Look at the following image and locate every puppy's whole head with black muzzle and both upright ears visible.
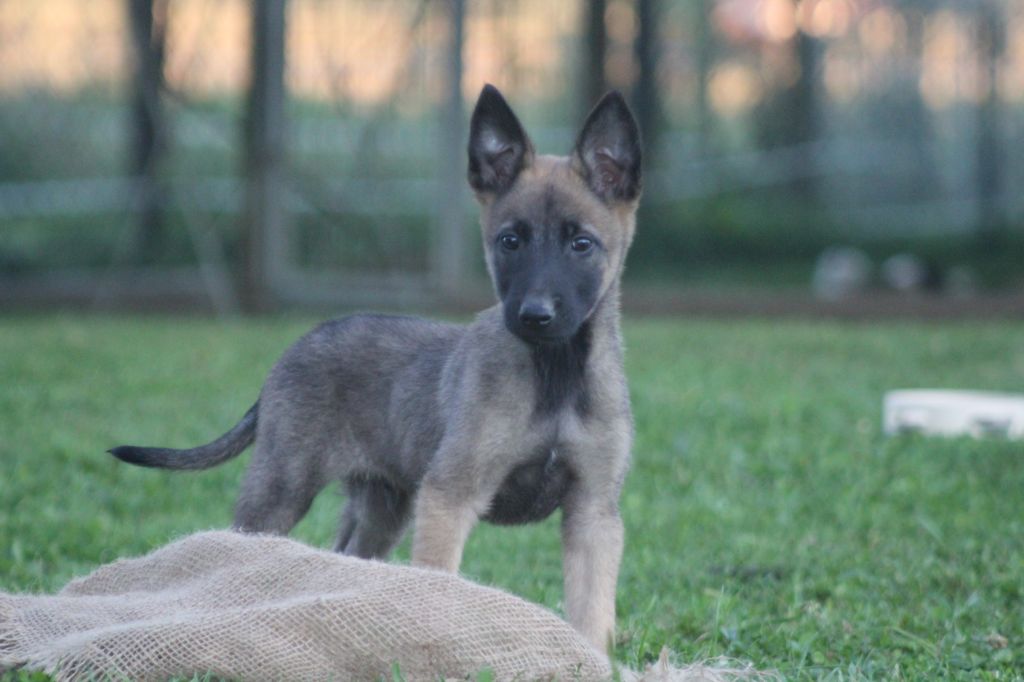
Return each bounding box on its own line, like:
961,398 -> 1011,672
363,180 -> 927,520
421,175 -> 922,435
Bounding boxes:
469,85 -> 640,343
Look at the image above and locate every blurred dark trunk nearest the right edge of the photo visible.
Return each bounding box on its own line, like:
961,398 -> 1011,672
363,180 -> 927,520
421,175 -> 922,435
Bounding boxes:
976,2 -> 1006,246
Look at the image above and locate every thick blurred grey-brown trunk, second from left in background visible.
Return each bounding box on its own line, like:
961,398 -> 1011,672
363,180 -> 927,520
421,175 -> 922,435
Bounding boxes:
242,0 -> 288,312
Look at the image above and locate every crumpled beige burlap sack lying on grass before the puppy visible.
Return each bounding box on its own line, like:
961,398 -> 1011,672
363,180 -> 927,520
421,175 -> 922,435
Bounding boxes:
0,531 -> 765,680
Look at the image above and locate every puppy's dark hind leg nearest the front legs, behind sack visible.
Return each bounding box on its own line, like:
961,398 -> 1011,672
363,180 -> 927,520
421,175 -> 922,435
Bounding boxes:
335,478 -> 411,559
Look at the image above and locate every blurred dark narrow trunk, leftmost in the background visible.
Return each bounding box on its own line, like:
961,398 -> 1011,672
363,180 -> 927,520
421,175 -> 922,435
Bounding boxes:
128,0 -> 167,264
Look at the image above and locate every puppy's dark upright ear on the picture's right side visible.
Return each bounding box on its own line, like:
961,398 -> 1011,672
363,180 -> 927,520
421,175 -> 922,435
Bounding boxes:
574,91 -> 643,204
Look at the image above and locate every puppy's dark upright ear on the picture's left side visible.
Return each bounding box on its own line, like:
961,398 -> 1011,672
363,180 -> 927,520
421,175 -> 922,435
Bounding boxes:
469,84 -> 534,196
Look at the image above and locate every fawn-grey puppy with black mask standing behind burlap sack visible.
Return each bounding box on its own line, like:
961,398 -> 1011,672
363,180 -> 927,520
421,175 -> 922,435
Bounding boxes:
111,85 -> 641,648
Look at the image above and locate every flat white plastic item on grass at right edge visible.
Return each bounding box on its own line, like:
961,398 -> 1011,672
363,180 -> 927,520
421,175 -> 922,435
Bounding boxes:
884,389 -> 1024,439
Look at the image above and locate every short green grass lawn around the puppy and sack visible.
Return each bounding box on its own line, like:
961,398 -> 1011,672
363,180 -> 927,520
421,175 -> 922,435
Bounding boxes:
0,316 -> 1024,680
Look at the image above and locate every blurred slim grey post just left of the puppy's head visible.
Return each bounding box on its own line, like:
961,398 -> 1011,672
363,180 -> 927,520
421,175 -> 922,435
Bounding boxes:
434,0 -> 466,299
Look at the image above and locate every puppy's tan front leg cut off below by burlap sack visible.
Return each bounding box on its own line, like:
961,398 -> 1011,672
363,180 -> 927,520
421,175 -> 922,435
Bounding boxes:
413,481 -> 477,572
